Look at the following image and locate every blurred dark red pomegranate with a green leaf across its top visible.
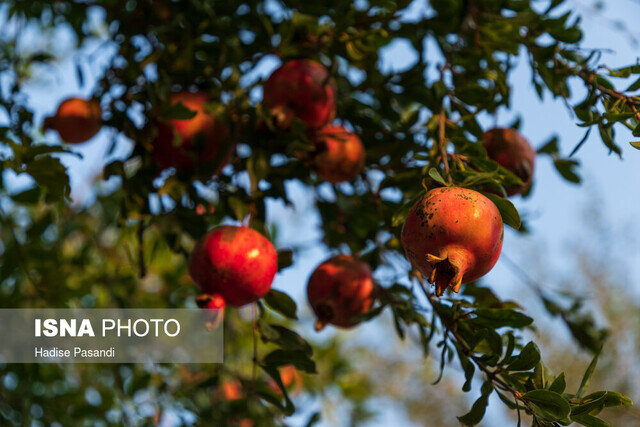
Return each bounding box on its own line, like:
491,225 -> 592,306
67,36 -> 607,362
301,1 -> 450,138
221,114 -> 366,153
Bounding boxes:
152,92 -> 233,175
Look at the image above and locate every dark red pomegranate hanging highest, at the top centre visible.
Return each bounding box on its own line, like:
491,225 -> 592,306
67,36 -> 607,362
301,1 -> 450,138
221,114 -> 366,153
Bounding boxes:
263,59 -> 337,129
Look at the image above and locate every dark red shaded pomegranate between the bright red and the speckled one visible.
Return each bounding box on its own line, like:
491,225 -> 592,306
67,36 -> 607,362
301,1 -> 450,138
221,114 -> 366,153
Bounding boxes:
307,255 -> 375,330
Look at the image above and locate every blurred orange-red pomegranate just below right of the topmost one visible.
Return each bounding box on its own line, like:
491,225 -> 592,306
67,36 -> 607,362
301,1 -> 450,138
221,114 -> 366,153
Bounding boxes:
313,125 -> 366,183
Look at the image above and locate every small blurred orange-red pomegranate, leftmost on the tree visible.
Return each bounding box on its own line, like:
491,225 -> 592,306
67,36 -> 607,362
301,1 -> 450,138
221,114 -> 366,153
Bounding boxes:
44,97 -> 102,144
